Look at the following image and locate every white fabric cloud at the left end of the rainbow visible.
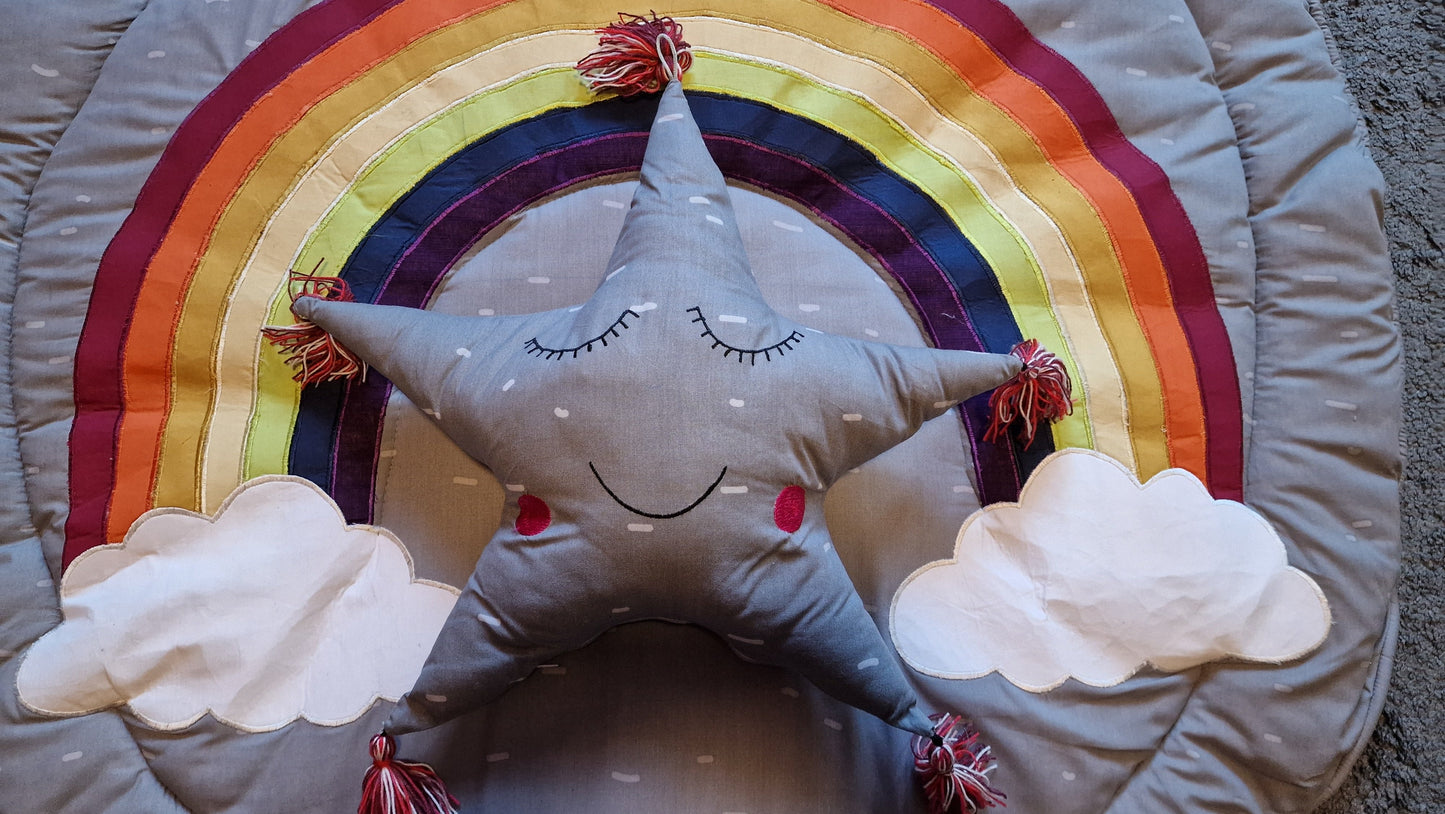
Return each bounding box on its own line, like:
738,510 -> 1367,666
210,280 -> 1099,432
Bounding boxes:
16,476 -> 457,732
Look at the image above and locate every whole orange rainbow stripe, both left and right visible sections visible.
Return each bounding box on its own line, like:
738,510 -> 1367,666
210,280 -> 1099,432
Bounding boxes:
107,0 -> 1205,539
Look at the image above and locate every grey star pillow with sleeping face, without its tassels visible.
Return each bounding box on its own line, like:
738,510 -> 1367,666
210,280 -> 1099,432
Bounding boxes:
295,81 -> 1020,736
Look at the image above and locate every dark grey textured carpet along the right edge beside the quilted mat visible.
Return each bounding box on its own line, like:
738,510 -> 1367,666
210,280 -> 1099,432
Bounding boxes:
1319,0 -> 1445,814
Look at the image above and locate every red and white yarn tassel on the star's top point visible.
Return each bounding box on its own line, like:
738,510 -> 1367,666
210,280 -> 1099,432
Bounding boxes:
577,12 -> 692,95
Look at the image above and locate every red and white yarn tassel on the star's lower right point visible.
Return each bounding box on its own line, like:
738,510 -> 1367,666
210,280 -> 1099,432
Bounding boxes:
913,713 -> 1006,814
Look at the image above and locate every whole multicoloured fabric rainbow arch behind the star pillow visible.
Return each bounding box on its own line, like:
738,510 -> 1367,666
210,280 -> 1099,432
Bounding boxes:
65,0 -> 1243,562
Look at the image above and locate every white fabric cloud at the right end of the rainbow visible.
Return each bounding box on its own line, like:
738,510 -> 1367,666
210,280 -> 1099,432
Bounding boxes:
892,450 -> 1329,693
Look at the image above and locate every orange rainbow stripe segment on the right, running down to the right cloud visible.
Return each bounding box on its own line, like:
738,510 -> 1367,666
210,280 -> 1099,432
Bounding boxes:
821,0 -> 1208,480
